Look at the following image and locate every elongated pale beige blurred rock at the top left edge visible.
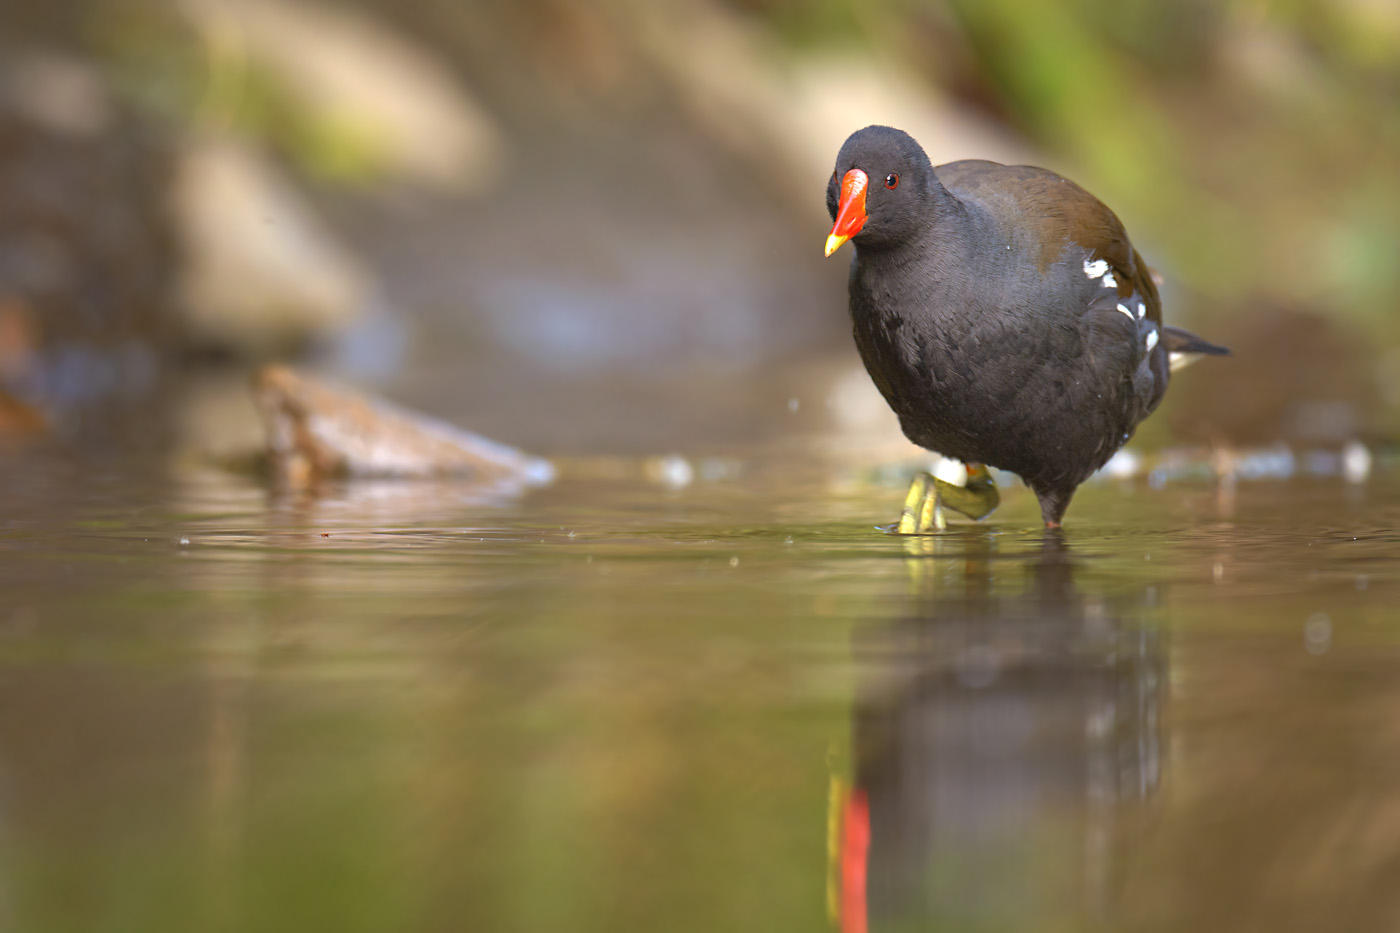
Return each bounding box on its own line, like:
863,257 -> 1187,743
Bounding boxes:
183,0 -> 503,192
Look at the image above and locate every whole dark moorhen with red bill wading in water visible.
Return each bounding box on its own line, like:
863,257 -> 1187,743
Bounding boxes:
826,126 -> 1229,534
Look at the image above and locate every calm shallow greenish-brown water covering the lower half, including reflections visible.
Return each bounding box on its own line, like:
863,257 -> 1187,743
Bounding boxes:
0,451 -> 1400,932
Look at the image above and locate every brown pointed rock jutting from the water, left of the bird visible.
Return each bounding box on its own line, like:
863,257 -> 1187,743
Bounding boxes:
253,366 -> 554,486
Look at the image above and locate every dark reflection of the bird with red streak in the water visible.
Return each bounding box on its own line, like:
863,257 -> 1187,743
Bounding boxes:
832,531 -> 1166,933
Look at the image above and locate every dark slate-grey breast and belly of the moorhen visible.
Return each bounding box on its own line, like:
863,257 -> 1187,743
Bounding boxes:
851,246 -> 1128,475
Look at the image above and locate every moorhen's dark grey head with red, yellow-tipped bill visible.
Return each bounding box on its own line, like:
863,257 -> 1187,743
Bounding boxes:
826,126 -> 934,256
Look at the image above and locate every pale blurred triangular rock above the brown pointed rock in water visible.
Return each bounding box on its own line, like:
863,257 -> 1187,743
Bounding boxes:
174,136 -> 372,356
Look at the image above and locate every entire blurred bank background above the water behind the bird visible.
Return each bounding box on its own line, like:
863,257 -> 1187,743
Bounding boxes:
0,0 -> 1400,452
